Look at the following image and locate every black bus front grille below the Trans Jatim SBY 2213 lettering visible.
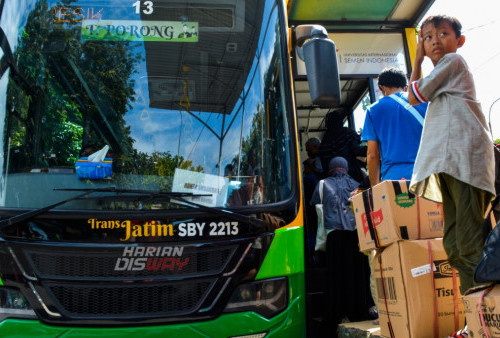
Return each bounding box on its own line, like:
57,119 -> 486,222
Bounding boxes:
0,233 -> 272,326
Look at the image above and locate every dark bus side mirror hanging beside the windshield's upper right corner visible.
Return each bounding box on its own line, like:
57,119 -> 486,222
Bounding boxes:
295,25 -> 340,108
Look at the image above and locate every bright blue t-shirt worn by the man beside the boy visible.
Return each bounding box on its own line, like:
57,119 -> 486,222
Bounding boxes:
361,92 -> 427,181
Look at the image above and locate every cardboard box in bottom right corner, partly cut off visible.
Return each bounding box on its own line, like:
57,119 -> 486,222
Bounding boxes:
464,285 -> 500,338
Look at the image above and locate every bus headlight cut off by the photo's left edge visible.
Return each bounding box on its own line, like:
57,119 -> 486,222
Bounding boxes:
0,287 -> 37,322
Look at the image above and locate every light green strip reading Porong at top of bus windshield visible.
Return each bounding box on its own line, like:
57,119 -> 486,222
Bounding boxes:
81,20 -> 198,42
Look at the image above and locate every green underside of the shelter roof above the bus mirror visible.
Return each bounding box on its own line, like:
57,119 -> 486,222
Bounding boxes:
288,0 -> 434,31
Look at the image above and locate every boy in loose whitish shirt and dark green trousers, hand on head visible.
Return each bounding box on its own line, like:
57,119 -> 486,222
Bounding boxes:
408,15 -> 495,337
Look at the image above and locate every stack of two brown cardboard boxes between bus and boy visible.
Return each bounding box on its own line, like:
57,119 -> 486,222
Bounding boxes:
352,181 -> 465,337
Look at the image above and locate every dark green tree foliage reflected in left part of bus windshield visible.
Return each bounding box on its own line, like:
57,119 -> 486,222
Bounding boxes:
7,1 -> 141,167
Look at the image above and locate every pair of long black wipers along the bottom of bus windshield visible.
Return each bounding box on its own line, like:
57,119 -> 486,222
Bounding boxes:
0,187 -> 265,230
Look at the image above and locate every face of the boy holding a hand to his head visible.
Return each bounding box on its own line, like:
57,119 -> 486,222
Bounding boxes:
422,21 -> 465,66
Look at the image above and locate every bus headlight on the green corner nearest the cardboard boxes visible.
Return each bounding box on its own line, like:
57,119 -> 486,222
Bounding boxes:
224,277 -> 288,318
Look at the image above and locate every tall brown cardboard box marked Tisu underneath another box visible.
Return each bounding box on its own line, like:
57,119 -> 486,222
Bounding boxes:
372,239 -> 465,338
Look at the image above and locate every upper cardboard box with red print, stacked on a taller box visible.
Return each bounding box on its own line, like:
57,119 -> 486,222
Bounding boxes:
352,181 -> 444,251
